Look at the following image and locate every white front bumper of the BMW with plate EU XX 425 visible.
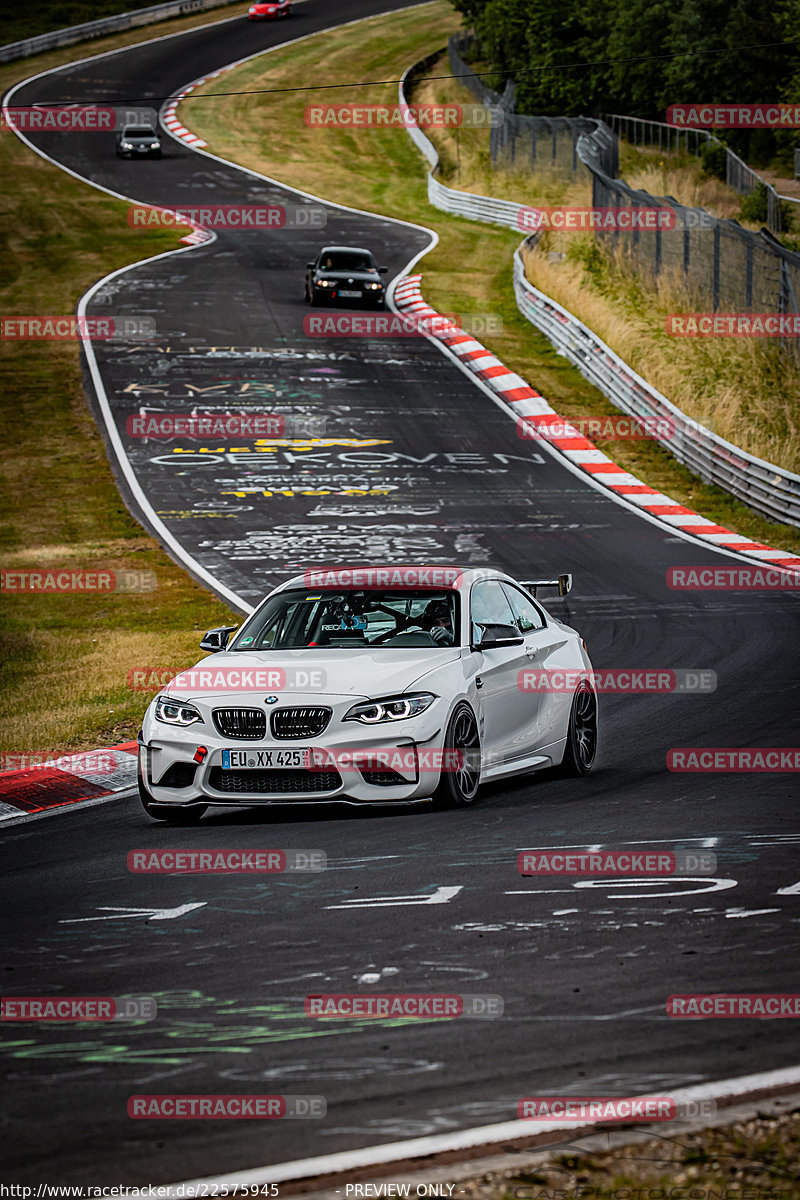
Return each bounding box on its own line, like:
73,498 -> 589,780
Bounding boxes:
139,698 -> 447,808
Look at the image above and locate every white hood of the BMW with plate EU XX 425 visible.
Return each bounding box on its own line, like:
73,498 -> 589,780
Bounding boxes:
164,646 -> 461,703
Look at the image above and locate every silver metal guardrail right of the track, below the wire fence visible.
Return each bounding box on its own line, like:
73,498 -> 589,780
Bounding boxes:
399,56 -> 800,526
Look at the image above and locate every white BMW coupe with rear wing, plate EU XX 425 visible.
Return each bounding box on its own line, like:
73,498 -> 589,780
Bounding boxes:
139,566 -> 597,824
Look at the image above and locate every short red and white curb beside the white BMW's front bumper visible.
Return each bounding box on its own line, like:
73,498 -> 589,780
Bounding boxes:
0,742 -> 139,821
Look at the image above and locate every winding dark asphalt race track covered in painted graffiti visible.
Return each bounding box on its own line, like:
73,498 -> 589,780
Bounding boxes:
0,0 -> 800,1184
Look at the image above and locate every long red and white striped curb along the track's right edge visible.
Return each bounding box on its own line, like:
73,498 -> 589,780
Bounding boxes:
395,275 -> 800,570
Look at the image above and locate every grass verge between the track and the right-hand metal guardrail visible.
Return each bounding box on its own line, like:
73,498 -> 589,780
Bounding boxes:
181,0 -> 800,552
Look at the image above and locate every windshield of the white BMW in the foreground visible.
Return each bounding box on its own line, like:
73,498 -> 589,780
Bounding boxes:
229,588 -> 459,650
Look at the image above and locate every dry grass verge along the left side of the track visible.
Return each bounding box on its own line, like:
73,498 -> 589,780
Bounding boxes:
0,14 -> 247,755
